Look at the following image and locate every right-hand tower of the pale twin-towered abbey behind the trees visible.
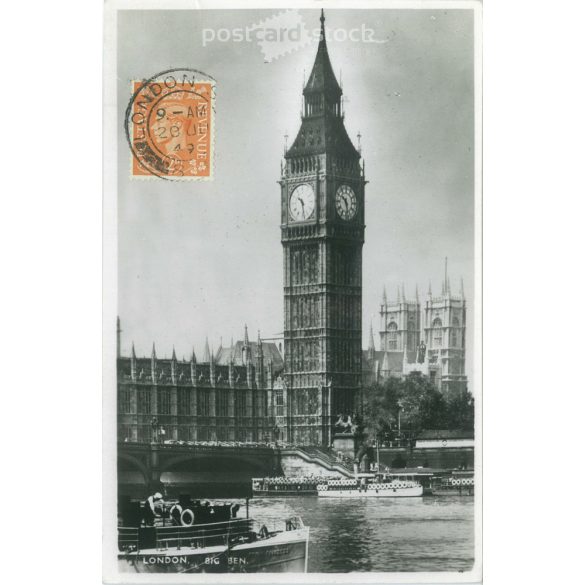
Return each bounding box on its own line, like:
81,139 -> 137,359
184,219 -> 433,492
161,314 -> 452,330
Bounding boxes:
424,258 -> 467,393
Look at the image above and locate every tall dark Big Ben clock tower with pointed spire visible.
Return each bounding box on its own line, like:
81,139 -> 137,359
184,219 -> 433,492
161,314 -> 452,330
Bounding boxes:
280,11 -> 366,445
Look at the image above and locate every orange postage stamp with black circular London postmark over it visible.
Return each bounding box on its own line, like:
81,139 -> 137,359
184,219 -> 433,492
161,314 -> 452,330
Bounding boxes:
124,68 -> 215,180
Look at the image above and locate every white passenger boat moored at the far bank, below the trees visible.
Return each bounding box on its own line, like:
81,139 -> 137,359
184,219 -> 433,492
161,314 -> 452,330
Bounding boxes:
317,473 -> 423,498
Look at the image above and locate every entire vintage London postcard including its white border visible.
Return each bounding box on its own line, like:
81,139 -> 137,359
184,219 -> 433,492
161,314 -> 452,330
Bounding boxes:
103,1 -> 482,583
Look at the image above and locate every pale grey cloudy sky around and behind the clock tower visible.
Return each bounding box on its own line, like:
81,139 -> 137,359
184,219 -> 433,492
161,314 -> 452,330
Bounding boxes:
118,10 -> 474,384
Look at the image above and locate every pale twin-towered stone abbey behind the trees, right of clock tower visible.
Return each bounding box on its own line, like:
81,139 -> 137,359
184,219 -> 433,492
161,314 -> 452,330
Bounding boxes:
363,270 -> 467,393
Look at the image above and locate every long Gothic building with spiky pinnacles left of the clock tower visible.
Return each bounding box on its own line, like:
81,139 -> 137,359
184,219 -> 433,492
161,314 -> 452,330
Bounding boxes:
117,324 -> 286,442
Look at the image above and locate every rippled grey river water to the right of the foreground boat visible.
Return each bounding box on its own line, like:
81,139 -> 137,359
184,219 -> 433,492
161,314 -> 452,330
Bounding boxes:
244,496 -> 474,572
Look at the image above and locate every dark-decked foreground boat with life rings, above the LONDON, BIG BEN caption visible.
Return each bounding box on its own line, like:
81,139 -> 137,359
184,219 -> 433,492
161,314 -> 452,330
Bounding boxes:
118,502 -> 309,573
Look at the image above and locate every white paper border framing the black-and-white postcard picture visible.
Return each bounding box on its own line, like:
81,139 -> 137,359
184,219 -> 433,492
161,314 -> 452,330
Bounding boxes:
102,0 -> 483,584
